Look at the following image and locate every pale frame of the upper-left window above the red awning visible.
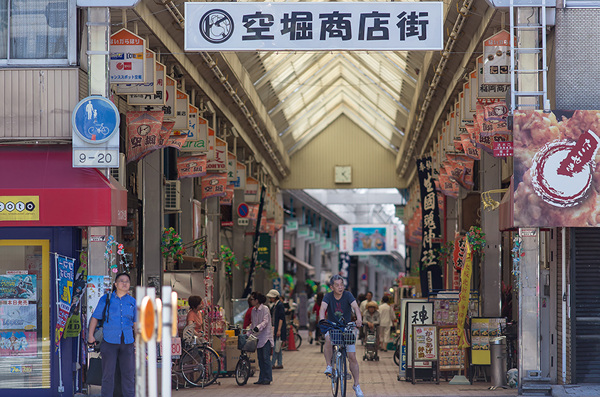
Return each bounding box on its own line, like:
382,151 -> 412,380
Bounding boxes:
0,0 -> 77,68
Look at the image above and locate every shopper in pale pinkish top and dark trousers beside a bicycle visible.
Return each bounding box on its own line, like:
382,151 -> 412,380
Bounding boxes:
250,292 -> 273,385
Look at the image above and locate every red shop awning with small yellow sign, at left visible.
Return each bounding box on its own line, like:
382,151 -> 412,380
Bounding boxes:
0,145 -> 127,227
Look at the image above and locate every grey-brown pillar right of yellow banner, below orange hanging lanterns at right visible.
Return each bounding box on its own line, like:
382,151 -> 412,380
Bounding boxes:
480,150 -> 503,317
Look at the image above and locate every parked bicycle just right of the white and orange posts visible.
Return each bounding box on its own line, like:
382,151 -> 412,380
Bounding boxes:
179,325 -> 221,387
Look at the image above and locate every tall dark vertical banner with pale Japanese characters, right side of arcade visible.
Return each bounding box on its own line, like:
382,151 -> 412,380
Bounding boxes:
417,157 -> 443,296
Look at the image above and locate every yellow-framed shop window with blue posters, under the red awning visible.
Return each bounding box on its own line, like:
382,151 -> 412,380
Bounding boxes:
0,240 -> 51,389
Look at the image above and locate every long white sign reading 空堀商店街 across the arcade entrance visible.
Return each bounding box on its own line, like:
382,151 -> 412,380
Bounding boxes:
184,2 -> 444,51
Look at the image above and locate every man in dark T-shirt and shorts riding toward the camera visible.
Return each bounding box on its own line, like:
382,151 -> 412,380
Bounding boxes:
319,274 -> 364,397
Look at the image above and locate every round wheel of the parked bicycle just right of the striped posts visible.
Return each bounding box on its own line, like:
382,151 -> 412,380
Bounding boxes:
180,348 -> 221,387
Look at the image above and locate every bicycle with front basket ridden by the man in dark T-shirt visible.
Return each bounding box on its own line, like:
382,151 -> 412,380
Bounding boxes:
319,320 -> 356,397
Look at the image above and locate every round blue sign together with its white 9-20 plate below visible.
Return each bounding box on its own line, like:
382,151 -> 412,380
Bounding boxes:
71,96 -> 121,168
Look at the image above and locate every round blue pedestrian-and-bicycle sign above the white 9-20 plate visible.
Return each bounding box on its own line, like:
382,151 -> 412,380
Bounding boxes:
71,96 -> 120,143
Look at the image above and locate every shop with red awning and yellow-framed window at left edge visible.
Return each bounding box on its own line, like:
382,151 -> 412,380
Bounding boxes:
0,145 -> 127,396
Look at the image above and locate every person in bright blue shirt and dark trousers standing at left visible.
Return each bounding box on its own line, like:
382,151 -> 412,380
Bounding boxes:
88,273 -> 137,397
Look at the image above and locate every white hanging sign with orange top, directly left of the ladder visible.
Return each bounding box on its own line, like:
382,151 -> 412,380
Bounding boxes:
483,30 -> 510,84
